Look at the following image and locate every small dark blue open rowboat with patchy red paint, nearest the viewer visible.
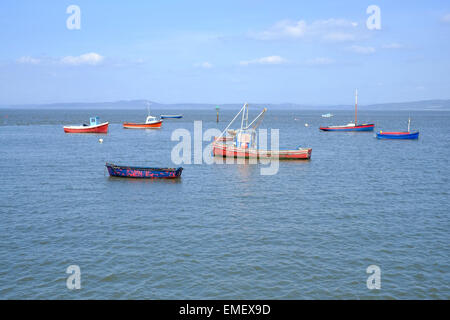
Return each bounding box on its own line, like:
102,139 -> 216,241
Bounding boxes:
105,162 -> 183,179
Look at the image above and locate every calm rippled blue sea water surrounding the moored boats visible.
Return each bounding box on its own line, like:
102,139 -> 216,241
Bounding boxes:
0,110 -> 450,299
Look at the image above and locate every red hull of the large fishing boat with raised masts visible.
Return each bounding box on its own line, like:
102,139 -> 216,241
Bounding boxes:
213,144 -> 312,160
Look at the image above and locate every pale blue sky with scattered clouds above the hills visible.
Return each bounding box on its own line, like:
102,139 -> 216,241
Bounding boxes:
0,0 -> 450,105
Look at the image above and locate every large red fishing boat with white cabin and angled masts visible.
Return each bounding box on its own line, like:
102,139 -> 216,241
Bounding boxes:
212,103 -> 312,160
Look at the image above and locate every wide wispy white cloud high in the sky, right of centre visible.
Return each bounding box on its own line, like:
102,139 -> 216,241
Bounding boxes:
251,18 -> 361,42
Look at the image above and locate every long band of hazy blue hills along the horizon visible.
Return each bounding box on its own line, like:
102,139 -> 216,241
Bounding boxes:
0,100 -> 450,111
